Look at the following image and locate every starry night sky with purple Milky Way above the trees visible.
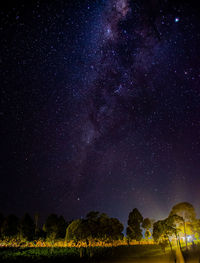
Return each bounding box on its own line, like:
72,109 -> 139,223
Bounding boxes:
0,0 -> 200,227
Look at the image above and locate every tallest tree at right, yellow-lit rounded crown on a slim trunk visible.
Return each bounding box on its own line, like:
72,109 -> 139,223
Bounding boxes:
169,202 -> 196,248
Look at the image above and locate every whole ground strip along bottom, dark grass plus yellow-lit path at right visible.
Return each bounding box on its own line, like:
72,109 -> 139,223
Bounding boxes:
0,245 -> 200,263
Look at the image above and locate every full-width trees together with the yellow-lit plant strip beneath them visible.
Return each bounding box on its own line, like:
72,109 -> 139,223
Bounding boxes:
0,202 -> 200,259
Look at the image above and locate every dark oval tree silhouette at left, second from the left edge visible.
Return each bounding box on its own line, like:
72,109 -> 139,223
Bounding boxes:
19,213 -> 35,240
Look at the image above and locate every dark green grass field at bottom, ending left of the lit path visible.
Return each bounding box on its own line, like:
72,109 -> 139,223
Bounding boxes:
0,245 -> 173,262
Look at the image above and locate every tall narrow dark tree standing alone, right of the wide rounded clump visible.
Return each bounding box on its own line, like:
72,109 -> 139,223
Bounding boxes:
126,208 -> 143,241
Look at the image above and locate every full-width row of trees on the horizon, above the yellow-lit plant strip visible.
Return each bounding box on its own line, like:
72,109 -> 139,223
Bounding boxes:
0,202 -> 200,248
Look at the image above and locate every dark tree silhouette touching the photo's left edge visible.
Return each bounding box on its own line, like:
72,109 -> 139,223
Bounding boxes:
1,215 -> 19,238
